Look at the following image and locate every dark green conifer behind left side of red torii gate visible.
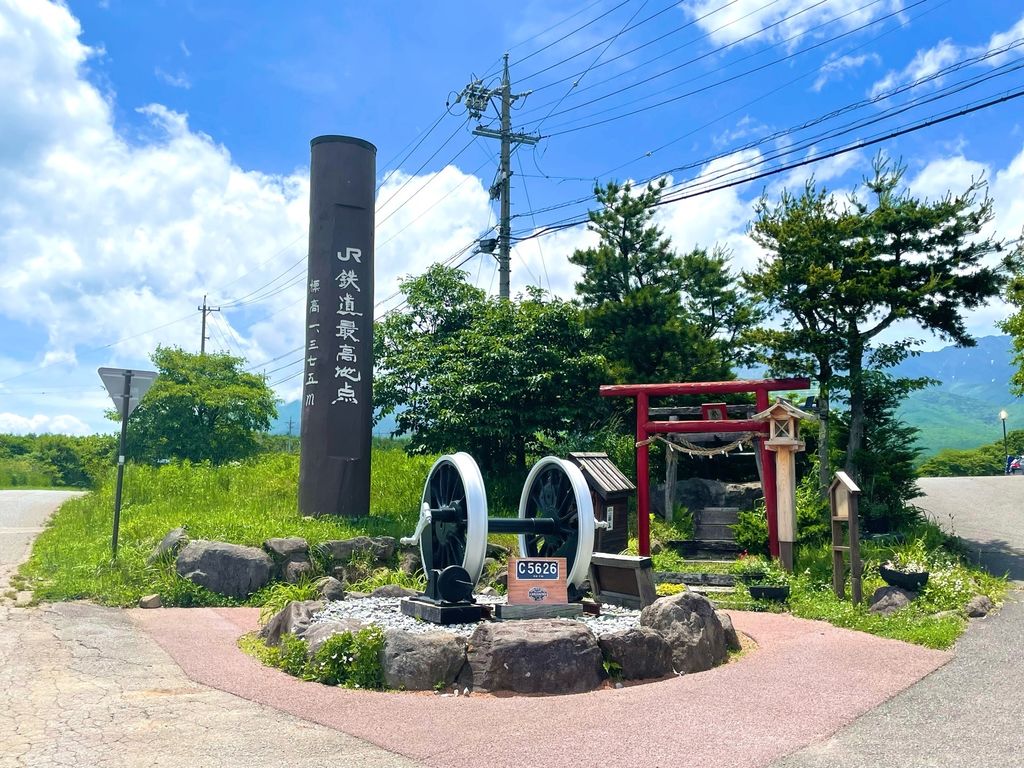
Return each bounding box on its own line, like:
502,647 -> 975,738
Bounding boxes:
569,179 -> 721,383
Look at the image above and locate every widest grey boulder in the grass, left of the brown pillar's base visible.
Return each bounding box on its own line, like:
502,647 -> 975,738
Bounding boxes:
174,541 -> 273,600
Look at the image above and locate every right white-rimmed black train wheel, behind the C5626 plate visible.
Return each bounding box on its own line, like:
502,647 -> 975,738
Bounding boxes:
519,456 -> 594,587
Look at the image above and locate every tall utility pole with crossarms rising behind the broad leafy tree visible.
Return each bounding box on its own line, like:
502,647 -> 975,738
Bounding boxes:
459,53 -> 541,299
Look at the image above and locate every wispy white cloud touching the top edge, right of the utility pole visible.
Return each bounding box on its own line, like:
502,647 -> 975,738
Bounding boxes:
686,0 -> 903,45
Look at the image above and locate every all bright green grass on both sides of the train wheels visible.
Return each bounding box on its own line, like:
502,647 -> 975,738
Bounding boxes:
16,447 -> 1008,648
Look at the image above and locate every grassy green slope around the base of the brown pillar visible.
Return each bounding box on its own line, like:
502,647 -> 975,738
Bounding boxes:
20,450 -> 433,605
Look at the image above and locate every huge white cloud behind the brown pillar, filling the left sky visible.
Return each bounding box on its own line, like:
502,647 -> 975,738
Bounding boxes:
0,0 -> 489,431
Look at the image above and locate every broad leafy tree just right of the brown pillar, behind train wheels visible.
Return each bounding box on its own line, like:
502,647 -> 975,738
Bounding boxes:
374,265 -> 605,469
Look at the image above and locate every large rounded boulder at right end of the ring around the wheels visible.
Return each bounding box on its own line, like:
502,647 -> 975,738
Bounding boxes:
640,591 -> 728,674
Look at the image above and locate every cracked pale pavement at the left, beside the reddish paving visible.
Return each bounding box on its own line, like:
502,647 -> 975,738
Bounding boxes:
0,492 -> 417,768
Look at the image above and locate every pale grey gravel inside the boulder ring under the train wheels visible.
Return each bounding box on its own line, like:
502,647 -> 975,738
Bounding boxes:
312,595 -> 640,637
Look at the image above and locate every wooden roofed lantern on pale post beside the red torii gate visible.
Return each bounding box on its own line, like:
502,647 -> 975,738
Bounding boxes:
753,398 -> 815,571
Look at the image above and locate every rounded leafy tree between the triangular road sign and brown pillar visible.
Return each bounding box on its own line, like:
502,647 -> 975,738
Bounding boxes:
123,346 -> 278,464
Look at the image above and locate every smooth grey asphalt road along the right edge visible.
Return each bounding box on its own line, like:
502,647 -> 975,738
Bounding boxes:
773,476 -> 1024,768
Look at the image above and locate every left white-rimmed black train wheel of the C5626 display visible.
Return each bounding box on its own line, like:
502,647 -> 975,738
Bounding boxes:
420,453 -> 487,587
